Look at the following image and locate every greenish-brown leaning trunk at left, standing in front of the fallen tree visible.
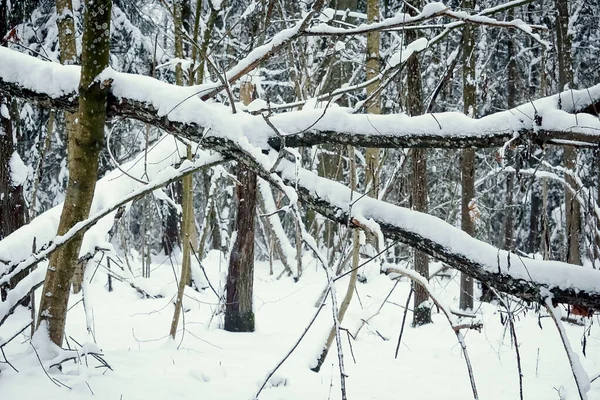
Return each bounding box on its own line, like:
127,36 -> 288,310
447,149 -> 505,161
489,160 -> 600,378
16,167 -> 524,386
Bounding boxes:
38,0 -> 112,346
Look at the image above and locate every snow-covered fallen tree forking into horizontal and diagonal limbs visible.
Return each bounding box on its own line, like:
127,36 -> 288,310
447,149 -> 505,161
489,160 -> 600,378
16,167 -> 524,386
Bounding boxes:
0,49 -> 600,309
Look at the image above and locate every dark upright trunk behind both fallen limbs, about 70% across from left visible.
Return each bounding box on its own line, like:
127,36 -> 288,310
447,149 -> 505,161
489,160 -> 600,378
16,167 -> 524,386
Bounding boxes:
405,0 -> 431,326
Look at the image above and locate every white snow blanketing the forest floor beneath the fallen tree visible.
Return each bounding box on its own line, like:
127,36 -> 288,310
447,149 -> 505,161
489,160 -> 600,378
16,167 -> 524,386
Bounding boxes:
0,253 -> 600,400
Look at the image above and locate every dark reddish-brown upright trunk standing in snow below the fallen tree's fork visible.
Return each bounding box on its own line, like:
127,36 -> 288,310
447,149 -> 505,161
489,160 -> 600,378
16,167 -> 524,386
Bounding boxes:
225,83 -> 257,332
